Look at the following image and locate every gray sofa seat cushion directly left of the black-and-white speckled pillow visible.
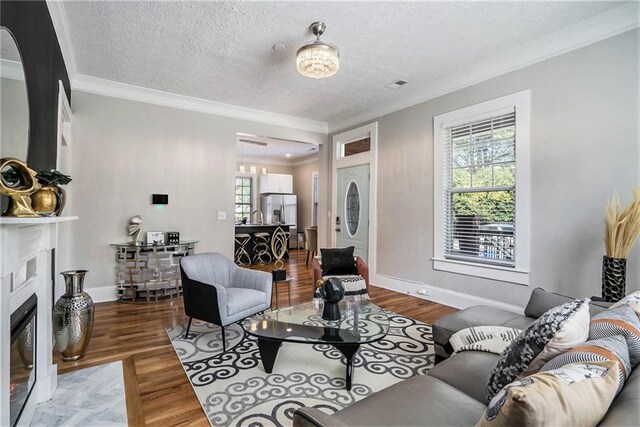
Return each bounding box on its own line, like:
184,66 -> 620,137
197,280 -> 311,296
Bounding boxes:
427,351 -> 498,405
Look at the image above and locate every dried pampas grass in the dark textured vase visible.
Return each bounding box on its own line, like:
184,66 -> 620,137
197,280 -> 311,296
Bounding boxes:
604,187 -> 640,258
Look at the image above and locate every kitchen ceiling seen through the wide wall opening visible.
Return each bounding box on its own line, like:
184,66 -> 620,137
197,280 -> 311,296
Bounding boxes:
236,133 -> 318,164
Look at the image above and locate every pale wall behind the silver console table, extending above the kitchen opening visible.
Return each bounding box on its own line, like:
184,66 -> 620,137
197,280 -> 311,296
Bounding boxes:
71,92 -> 327,299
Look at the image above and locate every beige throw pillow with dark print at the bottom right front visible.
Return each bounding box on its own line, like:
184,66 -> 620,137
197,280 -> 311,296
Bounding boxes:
476,361 -> 619,427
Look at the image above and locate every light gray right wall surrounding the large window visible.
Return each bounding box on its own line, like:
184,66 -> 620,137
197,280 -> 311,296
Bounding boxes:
338,29 -> 640,306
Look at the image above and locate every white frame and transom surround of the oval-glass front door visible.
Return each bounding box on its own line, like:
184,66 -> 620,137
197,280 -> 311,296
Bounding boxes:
329,122 -> 378,274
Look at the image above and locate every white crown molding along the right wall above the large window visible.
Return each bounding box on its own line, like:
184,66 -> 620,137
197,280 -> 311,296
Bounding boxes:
329,2 -> 640,133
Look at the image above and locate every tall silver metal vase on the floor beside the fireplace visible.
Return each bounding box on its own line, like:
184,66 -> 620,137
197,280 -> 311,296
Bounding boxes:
53,270 -> 93,362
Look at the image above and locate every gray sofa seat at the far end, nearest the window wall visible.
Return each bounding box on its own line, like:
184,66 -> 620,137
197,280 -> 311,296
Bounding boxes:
433,305 -> 524,346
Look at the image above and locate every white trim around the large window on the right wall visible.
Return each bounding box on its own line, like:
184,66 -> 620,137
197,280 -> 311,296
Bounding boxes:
432,89 -> 531,285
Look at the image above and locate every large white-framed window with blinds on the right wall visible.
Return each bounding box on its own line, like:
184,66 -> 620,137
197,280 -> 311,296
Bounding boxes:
434,91 -> 529,284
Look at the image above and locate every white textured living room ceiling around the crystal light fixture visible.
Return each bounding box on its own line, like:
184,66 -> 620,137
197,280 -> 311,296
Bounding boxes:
64,1 -> 623,123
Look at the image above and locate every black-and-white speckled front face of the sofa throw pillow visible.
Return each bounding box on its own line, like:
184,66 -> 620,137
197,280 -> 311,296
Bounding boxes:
487,298 -> 589,400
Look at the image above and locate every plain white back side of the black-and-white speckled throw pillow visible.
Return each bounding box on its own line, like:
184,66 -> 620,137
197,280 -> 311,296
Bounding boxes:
520,304 -> 590,377
